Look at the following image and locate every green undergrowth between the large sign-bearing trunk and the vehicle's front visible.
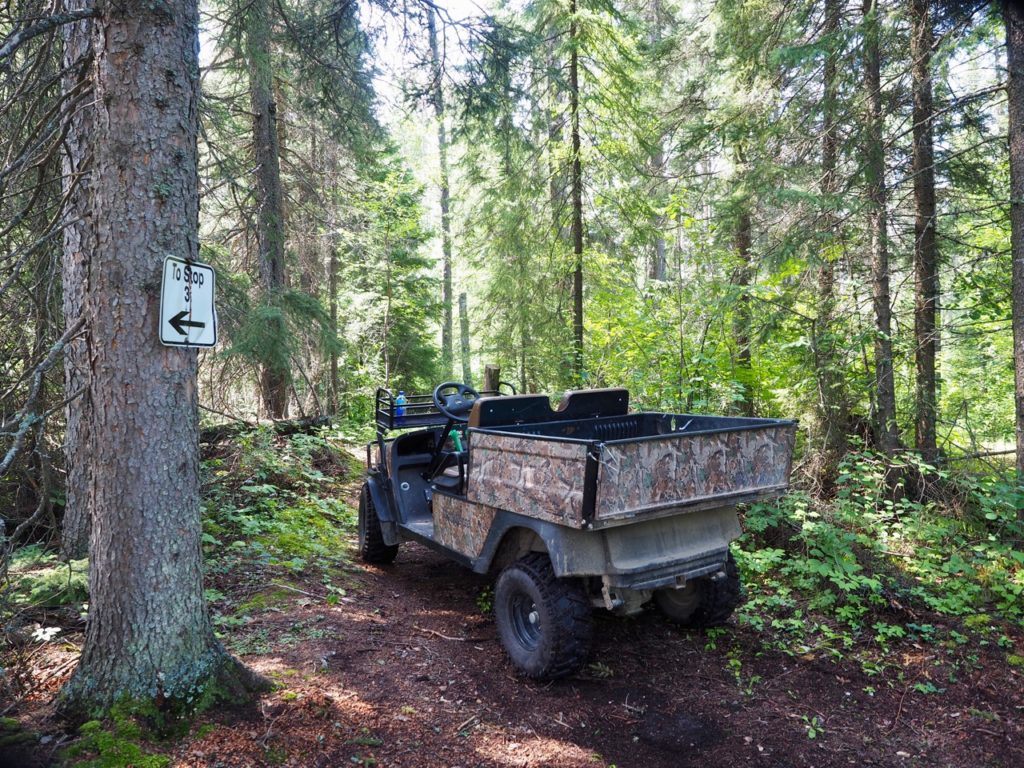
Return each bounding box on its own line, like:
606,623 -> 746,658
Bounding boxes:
203,428 -> 362,647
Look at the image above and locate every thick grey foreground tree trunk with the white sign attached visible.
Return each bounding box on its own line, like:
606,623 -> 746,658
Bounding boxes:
63,0 -> 262,712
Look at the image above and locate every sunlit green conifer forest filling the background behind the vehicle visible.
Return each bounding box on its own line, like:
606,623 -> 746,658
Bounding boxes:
2,0 -> 1015,475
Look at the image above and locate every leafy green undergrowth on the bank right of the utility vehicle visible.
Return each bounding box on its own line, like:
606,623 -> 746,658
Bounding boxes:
736,452 -> 1024,673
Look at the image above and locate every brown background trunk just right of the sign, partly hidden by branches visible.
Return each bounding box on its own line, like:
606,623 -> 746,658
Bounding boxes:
245,0 -> 290,419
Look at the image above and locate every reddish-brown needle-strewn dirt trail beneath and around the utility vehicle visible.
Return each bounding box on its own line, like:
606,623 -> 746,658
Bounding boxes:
0,434 -> 1024,768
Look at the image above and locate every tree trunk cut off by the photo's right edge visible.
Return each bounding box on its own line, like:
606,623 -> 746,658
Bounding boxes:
1002,0 -> 1024,481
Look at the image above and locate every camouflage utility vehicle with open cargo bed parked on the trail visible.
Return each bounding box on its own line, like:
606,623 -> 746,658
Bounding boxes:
358,382 -> 796,679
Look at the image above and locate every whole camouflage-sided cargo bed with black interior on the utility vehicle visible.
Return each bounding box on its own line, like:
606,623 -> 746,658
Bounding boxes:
466,411 -> 796,528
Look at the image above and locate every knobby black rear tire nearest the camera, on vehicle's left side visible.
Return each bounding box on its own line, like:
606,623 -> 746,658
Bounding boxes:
495,552 -> 594,680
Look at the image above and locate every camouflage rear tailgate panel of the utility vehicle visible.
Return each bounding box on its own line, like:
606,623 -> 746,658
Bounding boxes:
594,417 -> 797,522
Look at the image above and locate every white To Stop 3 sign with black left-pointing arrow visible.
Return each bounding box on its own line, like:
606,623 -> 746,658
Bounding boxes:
160,256 -> 217,347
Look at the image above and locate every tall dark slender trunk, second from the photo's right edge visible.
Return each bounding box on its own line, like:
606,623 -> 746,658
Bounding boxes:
910,0 -> 939,464
